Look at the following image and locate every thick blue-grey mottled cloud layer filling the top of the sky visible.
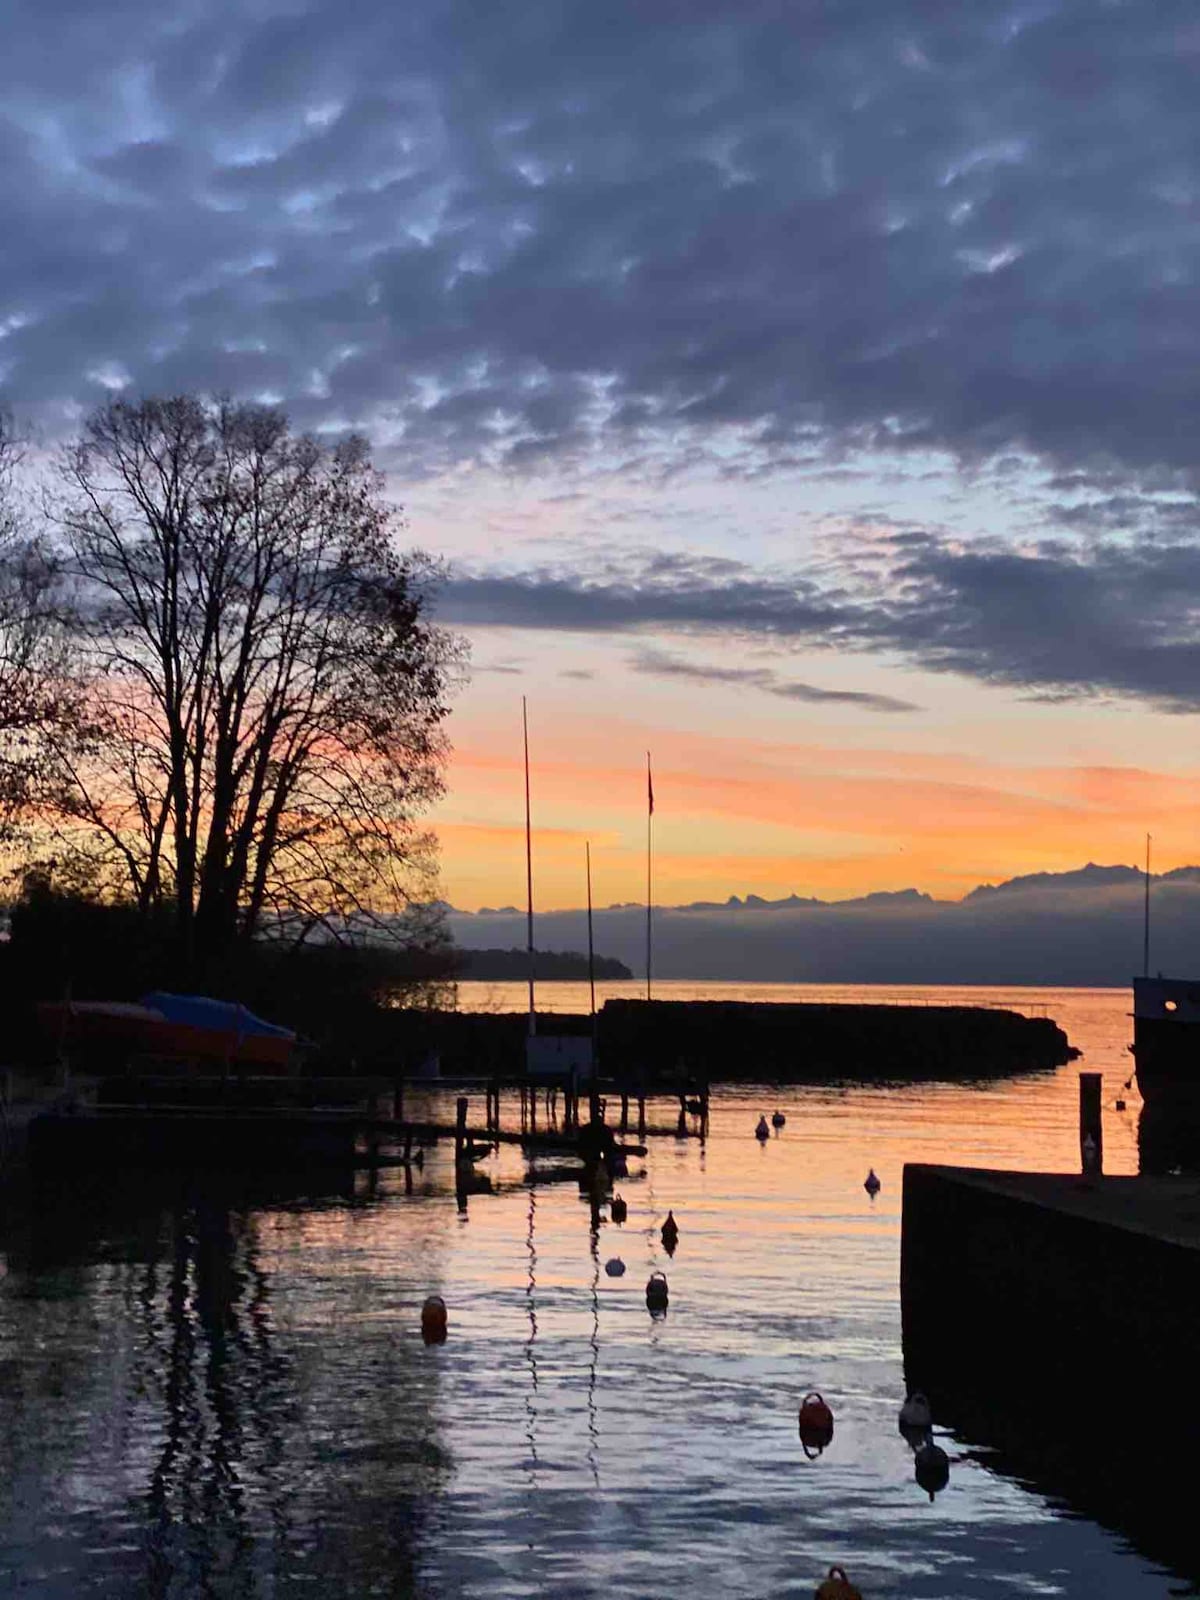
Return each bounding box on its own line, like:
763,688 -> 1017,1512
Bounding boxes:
0,0 -> 1200,472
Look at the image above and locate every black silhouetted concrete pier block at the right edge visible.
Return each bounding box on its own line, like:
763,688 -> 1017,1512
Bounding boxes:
901,1166 -> 1200,1578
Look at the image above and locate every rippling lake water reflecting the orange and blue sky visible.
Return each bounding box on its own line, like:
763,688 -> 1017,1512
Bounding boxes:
0,984 -> 1194,1600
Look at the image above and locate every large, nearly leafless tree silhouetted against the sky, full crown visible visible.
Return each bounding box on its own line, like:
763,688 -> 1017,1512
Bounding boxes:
32,397 -> 461,965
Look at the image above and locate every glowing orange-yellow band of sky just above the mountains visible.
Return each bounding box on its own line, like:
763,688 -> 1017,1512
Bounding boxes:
435,738 -> 1200,910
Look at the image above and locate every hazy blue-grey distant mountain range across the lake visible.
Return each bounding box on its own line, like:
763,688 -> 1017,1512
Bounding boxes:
448,862 -> 1200,986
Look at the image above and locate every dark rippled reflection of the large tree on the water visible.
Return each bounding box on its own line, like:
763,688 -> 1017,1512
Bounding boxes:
0,1181 -> 443,1597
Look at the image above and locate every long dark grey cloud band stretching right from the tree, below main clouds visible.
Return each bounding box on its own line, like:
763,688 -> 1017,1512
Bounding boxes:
443,530 -> 1200,712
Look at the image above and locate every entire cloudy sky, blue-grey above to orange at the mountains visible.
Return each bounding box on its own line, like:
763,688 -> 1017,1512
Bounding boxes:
0,0 -> 1200,907
